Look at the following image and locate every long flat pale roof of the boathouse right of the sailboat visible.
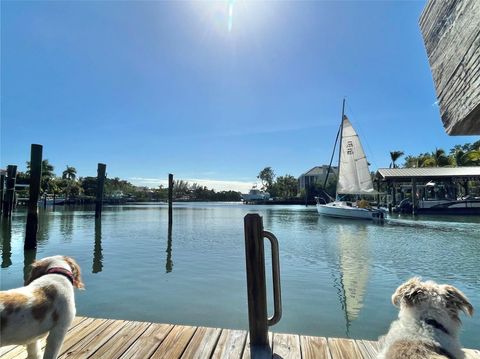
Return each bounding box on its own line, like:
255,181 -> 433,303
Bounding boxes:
375,166 -> 480,181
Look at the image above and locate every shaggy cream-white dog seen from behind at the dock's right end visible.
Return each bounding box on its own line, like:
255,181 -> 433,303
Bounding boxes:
377,278 -> 473,359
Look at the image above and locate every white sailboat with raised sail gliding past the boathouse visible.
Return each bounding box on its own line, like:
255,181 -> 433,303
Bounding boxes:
317,100 -> 384,220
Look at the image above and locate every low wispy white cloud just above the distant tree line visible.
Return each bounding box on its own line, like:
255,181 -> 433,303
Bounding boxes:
129,177 -> 260,193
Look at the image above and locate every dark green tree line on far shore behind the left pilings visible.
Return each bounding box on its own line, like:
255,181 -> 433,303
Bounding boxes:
13,159 -> 241,201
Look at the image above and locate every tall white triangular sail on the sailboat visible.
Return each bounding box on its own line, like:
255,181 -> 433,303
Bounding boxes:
337,116 -> 376,194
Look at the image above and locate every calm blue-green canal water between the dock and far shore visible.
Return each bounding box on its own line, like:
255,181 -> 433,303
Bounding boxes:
0,203 -> 480,348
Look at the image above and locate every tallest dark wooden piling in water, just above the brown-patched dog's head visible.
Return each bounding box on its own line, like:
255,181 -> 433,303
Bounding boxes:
23,144 -> 43,250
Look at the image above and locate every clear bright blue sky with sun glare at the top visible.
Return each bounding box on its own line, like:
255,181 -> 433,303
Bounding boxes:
0,0 -> 479,192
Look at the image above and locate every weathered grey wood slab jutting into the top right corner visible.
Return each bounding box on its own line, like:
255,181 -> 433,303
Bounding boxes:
419,0 -> 480,135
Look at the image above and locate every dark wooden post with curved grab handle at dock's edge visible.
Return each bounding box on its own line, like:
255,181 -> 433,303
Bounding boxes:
244,213 -> 282,358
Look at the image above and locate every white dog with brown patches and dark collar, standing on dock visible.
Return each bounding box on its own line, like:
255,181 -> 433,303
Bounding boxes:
0,256 -> 84,359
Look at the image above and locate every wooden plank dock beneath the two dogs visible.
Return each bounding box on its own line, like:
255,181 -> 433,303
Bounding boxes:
0,317 -> 480,359
